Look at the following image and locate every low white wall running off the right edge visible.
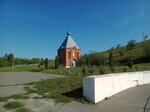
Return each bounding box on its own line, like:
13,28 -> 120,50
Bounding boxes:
83,71 -> 150,103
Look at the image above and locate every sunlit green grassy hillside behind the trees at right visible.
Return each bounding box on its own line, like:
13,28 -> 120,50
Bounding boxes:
96,40 -> 150,64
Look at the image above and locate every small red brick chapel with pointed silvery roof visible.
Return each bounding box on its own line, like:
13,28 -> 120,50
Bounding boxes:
58,32 -> 80,68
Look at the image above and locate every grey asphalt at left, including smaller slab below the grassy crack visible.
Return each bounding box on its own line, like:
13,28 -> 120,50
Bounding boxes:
0,72 -> 64,96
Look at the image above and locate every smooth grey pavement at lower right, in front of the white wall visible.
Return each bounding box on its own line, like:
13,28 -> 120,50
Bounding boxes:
53,84 -> 150,112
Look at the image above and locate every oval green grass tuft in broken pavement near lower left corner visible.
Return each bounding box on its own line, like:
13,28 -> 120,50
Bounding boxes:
4,101 -> 24,110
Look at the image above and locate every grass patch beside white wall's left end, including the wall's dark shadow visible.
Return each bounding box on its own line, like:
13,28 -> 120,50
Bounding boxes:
30,76 -> 83,102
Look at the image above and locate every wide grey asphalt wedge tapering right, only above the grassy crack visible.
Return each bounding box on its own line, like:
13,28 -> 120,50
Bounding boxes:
0,72 -> 64,86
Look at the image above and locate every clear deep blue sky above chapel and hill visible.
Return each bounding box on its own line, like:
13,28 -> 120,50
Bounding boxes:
0,0 -> 150,58
